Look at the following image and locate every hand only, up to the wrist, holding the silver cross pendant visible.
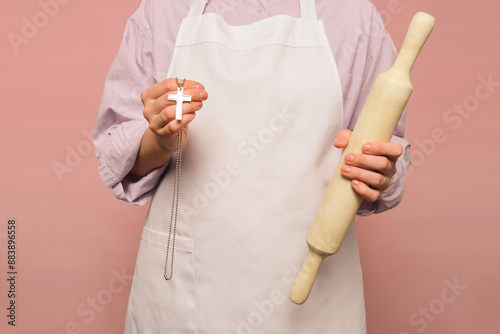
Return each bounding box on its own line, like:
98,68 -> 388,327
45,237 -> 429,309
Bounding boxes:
141,78 -> 208,151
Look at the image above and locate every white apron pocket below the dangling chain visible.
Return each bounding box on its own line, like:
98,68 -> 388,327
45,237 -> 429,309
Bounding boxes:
126,227 -> 196,334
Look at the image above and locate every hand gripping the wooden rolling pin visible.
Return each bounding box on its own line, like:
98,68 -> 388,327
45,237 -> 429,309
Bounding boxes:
334,130 -> 403,202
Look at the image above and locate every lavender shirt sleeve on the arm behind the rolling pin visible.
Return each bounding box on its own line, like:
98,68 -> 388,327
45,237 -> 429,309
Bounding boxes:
348,7 -> 411,216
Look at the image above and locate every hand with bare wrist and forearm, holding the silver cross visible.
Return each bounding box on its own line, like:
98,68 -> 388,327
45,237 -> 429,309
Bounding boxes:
129,78 -> 208,177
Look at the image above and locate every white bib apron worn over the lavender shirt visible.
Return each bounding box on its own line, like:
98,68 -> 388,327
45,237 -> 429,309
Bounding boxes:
125,0 -> 365,334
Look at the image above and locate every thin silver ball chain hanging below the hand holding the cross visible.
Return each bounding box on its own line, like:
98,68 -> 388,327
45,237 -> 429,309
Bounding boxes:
163,129 -> 182,281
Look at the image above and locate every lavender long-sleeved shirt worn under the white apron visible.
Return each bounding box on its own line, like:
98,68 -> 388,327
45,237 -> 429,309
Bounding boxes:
94,0 -> 410,215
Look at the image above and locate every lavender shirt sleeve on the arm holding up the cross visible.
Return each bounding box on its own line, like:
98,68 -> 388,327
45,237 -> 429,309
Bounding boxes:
94,2 -> 166,205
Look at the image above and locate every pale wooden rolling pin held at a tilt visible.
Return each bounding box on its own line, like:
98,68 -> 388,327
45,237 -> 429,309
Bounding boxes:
290,12 -> 435,305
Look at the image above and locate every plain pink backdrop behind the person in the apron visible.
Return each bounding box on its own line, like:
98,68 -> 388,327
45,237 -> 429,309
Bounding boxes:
0,0 -> 500,334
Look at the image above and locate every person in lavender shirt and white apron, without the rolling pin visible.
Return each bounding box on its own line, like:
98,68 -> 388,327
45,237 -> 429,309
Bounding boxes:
95,0 -> 410,333
